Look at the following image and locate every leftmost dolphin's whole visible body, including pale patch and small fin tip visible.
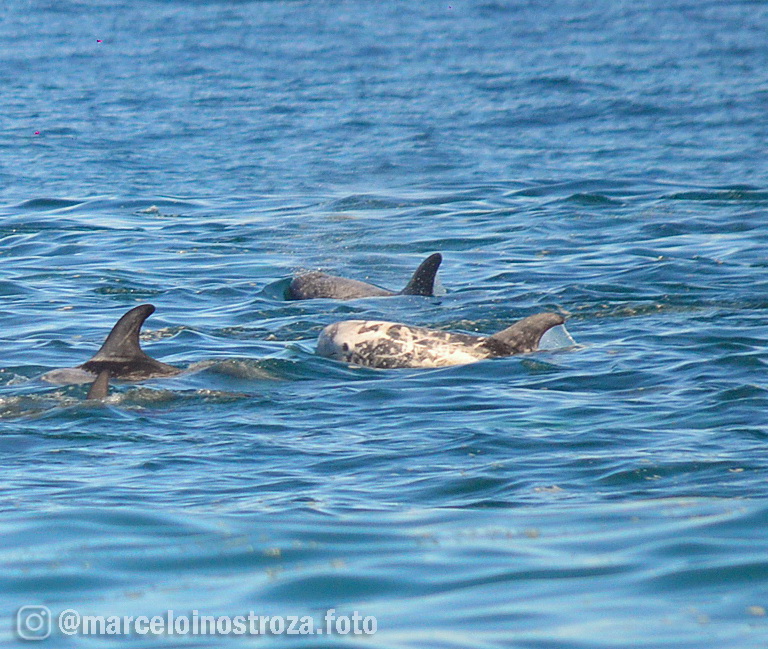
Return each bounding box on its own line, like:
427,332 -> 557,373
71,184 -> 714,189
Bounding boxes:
42,304 -> 182,384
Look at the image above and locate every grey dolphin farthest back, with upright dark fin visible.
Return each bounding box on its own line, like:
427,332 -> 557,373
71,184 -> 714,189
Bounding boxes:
286,252 -> 443,300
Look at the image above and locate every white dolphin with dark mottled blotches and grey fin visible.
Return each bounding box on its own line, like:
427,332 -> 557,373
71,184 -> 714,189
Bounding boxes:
317,313 -> 565,368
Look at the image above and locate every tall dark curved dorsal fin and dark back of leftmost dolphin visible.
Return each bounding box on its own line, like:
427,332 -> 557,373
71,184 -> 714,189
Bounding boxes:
80,304 -> 181,380
